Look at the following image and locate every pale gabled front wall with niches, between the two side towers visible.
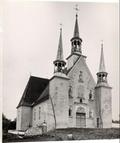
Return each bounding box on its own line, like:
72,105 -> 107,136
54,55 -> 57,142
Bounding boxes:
68,57 -> 96,128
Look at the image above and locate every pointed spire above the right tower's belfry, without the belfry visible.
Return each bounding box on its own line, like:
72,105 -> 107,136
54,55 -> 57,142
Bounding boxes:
99,43 -> 106,72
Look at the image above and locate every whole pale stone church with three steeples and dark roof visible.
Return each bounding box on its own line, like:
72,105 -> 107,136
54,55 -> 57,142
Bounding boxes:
17,11 -> 112,131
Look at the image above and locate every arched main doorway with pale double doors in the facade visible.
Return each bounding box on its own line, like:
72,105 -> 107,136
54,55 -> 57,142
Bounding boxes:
76,107 -> 86,128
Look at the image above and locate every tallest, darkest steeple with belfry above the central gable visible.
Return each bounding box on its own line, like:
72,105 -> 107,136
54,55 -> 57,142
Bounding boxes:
71,14 -> 82,55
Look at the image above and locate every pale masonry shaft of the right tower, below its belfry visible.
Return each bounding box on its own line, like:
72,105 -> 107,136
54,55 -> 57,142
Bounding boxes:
95,86 -> 112,128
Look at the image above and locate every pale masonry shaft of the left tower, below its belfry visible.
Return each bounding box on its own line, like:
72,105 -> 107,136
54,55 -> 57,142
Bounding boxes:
50,76 -> 68,128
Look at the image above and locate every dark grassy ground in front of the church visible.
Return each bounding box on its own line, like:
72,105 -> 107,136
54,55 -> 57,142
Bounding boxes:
3,128 -> 120,142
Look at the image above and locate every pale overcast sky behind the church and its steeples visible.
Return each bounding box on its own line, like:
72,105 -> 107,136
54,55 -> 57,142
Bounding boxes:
0,1 -> 119,119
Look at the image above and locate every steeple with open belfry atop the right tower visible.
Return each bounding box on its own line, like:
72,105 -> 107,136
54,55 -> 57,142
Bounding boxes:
97,43 -> 108,83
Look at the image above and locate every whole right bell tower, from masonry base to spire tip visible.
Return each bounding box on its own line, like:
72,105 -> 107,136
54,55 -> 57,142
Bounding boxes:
95,43 -> 112,128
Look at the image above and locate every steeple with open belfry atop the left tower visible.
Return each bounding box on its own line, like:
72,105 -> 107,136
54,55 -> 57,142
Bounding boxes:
53,28 -> 66,73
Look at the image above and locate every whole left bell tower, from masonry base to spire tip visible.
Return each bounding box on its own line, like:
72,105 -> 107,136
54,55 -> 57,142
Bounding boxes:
48,28 -> 69,129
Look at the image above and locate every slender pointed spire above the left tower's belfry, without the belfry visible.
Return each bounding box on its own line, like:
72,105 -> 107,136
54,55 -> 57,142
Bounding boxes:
56,28 -> 63,61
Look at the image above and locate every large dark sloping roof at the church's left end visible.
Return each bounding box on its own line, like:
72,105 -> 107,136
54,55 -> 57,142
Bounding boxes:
17,76 -> 49,108
